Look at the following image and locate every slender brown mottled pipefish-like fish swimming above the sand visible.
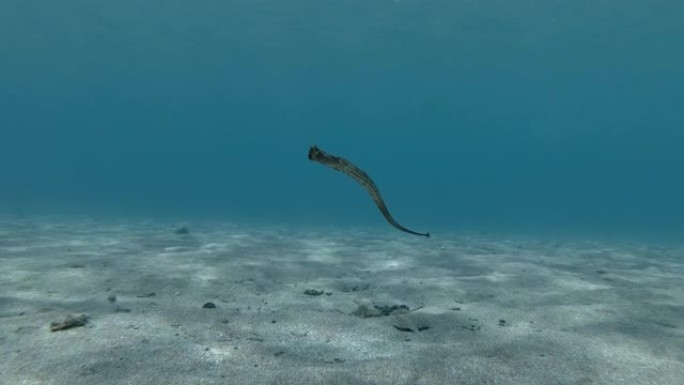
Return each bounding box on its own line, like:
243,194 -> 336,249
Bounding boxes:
309,146 -> 430,238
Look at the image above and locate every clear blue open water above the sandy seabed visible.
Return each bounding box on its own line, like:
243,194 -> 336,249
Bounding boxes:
0,0 -> 684,234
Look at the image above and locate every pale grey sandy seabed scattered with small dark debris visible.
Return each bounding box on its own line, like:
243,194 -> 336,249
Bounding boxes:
0,218 -> 684,385
